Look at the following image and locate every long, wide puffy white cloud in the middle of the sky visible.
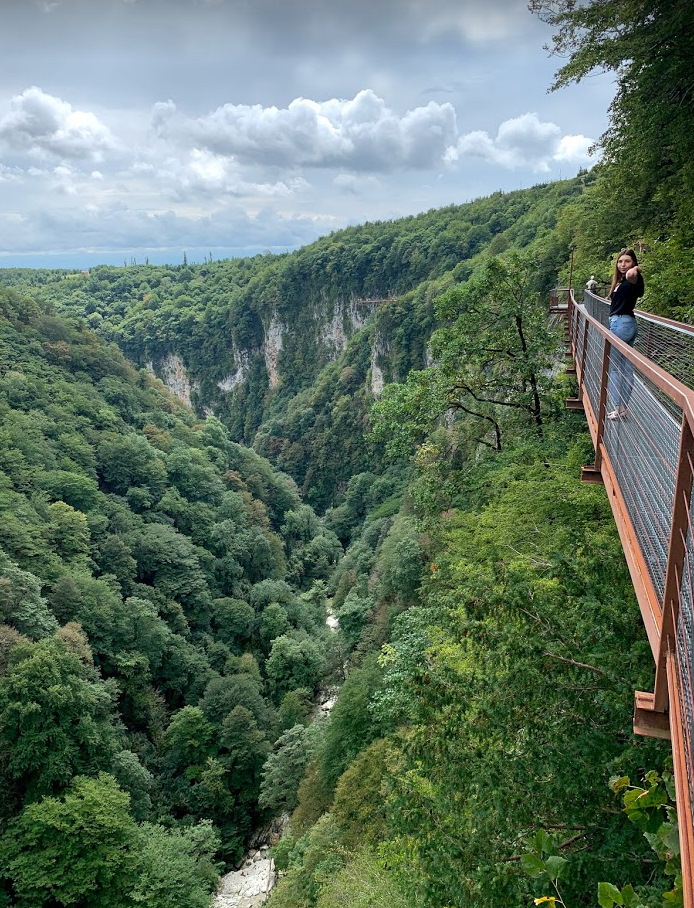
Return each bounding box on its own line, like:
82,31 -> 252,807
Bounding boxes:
152,89 -> 456,172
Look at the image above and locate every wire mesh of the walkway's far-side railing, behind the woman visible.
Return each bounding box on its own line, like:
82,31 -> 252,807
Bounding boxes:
583,290 -> 694,388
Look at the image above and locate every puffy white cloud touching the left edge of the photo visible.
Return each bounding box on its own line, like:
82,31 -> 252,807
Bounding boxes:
0,86 -> 114,161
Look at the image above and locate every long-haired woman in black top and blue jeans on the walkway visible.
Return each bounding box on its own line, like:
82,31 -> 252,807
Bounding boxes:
607,249 -> 645,419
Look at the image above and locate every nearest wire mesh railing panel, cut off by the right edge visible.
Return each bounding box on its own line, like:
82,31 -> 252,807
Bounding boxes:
676,490 -> 694,836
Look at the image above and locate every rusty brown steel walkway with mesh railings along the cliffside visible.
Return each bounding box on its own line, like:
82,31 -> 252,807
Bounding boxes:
564,290 -> 694,908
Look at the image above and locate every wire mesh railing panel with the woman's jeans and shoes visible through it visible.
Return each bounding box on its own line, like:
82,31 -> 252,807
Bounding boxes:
603,366 -> 682,605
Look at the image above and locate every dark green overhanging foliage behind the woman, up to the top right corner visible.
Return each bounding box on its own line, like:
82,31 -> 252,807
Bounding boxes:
530,0 -> 694,317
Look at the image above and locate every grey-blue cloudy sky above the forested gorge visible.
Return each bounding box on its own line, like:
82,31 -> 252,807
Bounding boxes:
0,0 -> 612,267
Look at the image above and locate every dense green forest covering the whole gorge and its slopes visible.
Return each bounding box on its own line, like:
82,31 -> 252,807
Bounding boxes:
0,0 -> 694,908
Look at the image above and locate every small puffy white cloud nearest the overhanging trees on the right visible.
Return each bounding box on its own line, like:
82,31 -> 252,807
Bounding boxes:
446,113 -> 592,172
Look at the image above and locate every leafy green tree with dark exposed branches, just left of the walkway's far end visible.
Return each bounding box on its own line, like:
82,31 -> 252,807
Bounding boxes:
373,254 -> 558,454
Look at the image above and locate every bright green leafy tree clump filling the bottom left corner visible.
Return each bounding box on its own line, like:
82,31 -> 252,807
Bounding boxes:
0,773 -> 219,908
